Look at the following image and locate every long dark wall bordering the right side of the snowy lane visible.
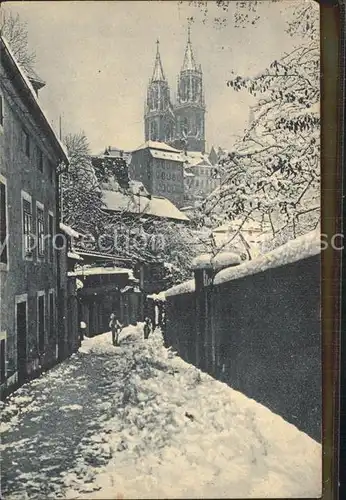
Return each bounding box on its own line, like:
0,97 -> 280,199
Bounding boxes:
165,236 -> 322,441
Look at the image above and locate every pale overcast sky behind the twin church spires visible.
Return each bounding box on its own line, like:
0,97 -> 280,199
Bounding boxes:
6,0 -> 304,153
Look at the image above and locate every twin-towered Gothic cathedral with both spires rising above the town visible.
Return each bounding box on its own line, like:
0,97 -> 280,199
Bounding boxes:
144,28 -> 205,153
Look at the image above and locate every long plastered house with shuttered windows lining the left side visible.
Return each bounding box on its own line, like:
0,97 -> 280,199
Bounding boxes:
0,37 -> 68,398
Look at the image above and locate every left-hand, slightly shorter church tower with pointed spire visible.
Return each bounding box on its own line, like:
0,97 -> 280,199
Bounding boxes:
144,40 -> 175,143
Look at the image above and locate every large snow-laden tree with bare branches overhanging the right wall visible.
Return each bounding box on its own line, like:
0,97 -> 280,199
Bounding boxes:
197,1 -> 320,248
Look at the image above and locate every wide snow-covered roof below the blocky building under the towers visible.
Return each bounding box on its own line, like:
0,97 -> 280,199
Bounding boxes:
102,191 -> 189,221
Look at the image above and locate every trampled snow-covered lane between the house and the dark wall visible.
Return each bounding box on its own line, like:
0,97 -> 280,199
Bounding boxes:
1,327 -> 321,500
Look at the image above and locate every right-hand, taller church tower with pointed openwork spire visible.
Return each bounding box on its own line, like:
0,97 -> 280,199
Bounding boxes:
174,26 -> 205,153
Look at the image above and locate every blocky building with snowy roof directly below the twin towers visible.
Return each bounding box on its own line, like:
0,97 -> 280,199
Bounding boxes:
129,141 -> 184,207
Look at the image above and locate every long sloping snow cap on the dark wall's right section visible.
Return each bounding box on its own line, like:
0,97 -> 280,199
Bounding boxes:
214,231 -> 321,285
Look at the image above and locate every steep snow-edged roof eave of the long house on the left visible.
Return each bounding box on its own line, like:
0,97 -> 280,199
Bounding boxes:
0,35 -> 68,163
